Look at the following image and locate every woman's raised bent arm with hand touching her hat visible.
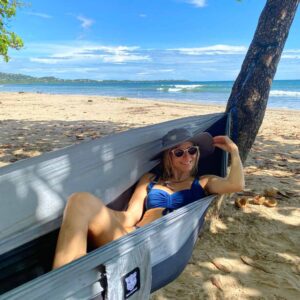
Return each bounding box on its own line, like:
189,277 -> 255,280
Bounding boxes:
201,136 -> 245,194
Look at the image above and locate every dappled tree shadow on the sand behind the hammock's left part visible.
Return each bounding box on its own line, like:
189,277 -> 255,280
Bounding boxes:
0,120 -> 142,166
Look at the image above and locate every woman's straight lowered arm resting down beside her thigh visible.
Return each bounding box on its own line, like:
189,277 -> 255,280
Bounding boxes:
114,173 -> 153,227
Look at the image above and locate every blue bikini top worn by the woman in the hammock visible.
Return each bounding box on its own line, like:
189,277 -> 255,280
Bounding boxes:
145,176 -> 206,210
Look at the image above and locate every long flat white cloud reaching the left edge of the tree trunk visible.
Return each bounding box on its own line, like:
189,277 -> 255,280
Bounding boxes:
169,45 -> 247,55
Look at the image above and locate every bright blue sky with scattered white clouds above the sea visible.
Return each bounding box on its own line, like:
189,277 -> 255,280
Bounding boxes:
0,0 -> 300,81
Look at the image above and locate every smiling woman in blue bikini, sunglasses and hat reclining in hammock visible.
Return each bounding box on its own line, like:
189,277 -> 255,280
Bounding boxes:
53,128 -> 244,268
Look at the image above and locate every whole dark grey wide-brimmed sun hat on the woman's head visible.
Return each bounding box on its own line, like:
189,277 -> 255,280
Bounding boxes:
153,128 -> 215,160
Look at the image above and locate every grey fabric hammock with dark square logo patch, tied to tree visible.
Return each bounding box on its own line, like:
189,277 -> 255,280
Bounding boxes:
0,113 -> 229,299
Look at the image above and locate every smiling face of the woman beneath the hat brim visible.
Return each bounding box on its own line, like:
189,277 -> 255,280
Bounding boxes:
169,142 -> 199,173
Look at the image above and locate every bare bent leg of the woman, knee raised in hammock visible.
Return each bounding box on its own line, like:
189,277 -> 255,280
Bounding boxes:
53,192 -> 132,269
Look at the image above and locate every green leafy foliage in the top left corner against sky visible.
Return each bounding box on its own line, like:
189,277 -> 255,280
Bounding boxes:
0,0 -> 23,62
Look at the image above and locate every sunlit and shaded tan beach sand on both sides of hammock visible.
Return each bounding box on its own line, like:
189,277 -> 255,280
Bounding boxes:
0,93 -> 300,300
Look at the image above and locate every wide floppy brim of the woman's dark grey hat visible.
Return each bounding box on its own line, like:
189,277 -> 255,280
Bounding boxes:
151,132 -> 215,160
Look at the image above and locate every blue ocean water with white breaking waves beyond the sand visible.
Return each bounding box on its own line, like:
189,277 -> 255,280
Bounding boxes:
0,80 -> 300,110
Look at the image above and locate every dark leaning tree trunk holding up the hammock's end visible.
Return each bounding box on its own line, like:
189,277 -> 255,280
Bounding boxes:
226,0 -> 300,162
